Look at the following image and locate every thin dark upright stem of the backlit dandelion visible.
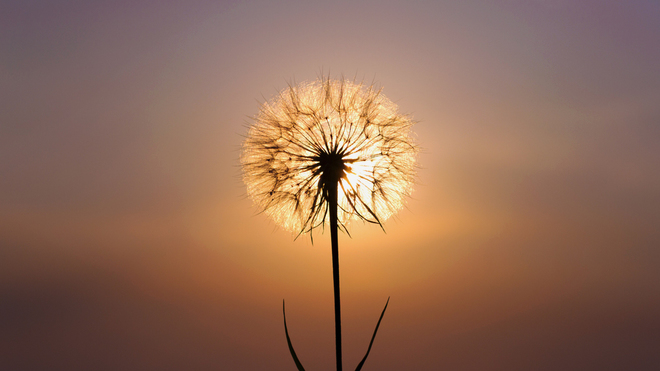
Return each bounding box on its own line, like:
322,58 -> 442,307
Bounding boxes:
327,179 -> 342,371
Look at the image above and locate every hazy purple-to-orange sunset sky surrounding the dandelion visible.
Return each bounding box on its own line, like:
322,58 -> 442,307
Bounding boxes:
0,0 -> 660,371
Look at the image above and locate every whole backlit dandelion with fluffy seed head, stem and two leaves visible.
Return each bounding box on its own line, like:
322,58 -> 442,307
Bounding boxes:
241,78 -> 417,371
